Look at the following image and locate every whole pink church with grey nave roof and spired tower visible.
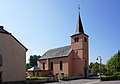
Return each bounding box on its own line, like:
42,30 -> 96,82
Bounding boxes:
37,13 -> 89,78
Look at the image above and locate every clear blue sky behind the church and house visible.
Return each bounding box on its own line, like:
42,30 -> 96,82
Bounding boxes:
0,0 -> 120,64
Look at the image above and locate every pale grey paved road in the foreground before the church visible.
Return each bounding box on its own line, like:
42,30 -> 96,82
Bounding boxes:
45,79 -> 120,84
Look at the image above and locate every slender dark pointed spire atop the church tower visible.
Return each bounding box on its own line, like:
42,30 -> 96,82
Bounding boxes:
76,5 -> 84,34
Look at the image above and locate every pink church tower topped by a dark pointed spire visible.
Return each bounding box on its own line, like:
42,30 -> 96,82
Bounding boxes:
71,8 -> 89,77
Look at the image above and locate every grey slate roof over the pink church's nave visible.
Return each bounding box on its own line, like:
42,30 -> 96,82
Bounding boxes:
40,45 -> 72,59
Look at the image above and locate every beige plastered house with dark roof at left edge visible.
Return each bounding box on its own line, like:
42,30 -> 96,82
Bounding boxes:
0,26 -> 27,84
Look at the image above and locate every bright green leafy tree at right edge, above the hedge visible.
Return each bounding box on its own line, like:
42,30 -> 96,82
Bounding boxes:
107,51 -> 120,72
